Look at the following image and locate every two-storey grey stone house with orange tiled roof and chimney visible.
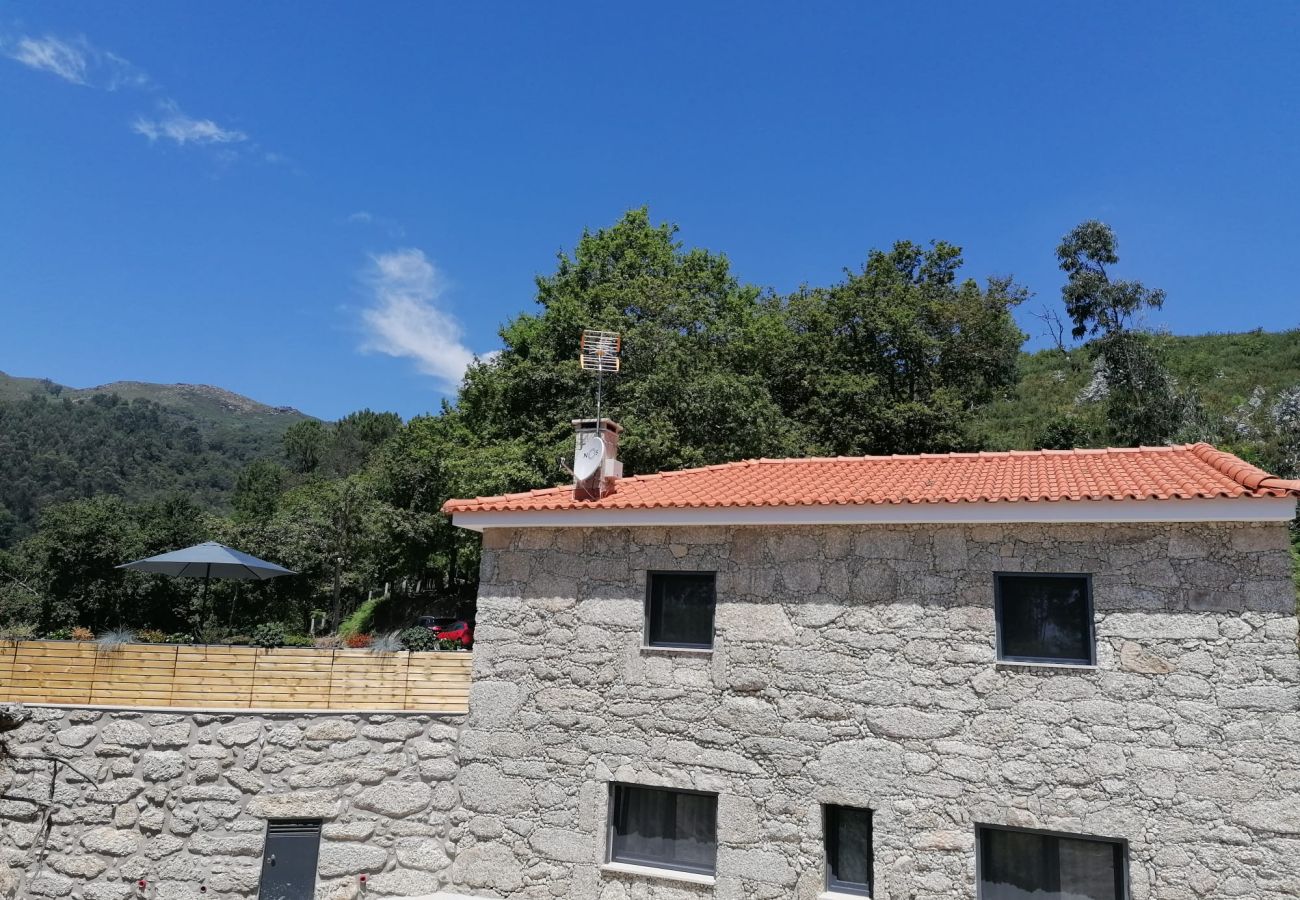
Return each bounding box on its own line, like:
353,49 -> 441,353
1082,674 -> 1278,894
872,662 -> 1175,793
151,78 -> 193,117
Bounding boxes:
446,431 -> 1300,900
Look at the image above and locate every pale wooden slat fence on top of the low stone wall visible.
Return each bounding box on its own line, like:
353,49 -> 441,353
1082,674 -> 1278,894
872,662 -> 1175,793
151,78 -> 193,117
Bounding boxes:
0,641 -> 472,713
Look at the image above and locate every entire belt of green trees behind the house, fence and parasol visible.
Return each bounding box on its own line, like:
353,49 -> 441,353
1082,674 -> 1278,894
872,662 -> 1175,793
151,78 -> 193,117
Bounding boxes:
0,209 -> 1300,637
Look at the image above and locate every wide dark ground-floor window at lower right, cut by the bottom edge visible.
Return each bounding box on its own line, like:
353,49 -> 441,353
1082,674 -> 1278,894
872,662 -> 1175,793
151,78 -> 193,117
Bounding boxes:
976,826 -> 1128,900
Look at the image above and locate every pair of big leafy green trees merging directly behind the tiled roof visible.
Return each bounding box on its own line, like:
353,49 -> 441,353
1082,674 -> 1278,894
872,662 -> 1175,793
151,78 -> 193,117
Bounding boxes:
455,209 -> 1024,473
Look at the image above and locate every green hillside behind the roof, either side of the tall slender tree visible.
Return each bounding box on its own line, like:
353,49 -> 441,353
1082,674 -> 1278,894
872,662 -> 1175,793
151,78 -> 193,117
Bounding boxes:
972,329 -> 1300,450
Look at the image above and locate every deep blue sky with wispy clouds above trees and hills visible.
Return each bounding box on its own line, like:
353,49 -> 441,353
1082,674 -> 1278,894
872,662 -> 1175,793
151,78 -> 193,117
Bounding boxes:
0,0 -> 1300,417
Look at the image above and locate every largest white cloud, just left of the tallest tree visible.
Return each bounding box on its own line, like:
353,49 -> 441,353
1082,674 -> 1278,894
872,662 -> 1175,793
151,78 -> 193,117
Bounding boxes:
361,248 -> 475,393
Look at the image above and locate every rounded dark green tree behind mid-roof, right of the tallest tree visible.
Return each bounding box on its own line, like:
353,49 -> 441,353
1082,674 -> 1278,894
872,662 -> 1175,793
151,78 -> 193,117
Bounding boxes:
780,241 -> 1026,454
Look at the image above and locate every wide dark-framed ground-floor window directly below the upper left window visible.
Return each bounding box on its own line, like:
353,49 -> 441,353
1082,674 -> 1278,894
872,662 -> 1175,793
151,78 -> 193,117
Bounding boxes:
610,784 -> 718,875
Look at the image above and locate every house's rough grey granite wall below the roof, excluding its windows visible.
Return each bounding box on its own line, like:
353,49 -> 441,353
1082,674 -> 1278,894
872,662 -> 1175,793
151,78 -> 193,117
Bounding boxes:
449,524 -> 1300,900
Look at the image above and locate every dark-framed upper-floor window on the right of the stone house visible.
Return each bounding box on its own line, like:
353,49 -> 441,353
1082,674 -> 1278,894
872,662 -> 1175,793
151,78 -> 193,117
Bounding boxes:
995,574 -> 1097,666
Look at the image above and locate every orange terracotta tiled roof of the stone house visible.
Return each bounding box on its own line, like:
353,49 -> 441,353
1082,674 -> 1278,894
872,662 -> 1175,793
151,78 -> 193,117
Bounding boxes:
442,443 -> 1300,514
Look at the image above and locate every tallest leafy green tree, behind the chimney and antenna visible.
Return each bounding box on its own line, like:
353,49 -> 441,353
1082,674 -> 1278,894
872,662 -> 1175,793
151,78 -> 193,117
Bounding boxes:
458,209 -> 798,486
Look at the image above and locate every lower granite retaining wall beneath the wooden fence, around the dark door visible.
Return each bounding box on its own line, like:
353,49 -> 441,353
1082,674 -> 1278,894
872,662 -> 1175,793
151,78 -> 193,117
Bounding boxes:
0,708 -> 460,900
